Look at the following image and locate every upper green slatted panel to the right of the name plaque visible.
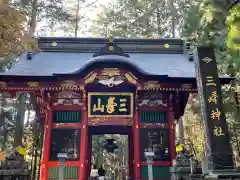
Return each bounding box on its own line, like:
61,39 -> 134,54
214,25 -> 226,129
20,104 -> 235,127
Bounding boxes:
140,111 -> 168,123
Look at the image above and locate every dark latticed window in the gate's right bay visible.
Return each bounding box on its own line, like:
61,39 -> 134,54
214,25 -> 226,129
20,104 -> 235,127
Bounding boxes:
140,128 -> 170,161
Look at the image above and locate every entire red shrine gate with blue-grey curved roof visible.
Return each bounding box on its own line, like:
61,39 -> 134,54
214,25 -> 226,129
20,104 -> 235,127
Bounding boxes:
0,37 -> 231,180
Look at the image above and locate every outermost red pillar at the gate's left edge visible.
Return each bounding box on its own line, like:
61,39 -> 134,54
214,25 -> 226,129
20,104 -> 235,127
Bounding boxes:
40,109 -> 52,180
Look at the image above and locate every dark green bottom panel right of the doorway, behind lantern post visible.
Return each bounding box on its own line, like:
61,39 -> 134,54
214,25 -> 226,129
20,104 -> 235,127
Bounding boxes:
141,166 -> 170,179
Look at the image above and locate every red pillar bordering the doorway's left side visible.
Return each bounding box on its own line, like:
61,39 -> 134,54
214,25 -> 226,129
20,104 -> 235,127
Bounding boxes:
79,96 -> 88,180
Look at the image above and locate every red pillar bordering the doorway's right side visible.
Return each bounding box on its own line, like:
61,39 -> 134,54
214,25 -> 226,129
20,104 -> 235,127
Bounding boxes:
133,108 -> 141,180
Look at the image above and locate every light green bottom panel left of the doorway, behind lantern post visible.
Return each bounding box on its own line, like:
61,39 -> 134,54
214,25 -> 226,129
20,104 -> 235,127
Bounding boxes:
48,166 -> 78,179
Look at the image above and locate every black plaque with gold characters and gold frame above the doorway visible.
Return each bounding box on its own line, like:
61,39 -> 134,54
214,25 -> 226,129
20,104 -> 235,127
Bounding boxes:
88,92 -> 133,117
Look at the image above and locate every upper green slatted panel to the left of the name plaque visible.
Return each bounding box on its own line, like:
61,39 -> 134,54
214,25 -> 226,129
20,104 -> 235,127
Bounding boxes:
53,111 -> 82,123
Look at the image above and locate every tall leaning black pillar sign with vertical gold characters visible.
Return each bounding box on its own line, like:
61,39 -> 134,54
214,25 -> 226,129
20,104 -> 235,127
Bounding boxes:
196,47 -> 233,170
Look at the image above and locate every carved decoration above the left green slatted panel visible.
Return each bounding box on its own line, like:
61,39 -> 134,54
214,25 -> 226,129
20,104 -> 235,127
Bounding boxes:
53,90 -> 82,106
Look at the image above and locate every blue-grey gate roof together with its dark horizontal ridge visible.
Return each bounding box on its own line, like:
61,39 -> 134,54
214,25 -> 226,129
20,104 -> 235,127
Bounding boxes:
2,38 -> 232,83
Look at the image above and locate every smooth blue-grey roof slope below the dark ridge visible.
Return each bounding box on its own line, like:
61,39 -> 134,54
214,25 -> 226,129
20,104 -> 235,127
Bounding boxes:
1,52 -> 195,77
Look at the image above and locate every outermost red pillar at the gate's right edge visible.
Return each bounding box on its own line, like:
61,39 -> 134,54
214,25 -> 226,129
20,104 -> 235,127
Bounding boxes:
168,100 -> 176,161
